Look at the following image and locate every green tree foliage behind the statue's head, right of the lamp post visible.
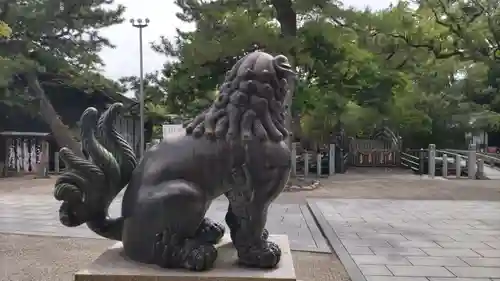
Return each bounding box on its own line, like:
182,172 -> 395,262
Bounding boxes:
117,0 -> 500,147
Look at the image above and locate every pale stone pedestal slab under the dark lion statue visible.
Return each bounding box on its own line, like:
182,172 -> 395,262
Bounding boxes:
75,235 -> 296,281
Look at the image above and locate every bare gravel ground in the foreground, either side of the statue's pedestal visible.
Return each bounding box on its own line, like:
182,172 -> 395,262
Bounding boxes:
0,234 -> 349,281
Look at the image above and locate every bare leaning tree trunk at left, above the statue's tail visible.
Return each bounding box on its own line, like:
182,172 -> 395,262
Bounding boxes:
26,73 -> 84,157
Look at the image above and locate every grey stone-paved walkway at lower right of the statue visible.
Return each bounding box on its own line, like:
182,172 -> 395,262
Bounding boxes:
308,199 -> 500,281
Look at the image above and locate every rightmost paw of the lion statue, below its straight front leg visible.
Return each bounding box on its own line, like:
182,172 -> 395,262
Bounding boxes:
238,241 -> 281,268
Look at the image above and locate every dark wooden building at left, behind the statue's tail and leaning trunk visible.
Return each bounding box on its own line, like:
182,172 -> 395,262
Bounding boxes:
0,82 -> 152,177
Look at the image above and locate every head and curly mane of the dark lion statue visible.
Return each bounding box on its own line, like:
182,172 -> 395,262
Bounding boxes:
186,51 -> 295,142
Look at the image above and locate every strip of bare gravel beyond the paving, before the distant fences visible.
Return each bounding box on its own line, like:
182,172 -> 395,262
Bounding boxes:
0,168 -> 500,204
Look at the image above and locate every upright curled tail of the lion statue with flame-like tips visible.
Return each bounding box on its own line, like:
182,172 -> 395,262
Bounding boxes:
54,103 -> 137,240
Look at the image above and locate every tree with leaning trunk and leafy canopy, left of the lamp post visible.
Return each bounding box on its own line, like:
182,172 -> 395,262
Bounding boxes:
0,0 -> 124,153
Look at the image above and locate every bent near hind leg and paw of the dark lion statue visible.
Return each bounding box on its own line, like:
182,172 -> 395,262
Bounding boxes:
123,181 -> 217,271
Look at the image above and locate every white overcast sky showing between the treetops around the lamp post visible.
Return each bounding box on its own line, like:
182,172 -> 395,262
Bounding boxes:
97,0 -> 396,79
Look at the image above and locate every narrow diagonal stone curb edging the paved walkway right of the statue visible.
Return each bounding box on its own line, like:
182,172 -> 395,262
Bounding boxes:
307,199 -> 367,281
